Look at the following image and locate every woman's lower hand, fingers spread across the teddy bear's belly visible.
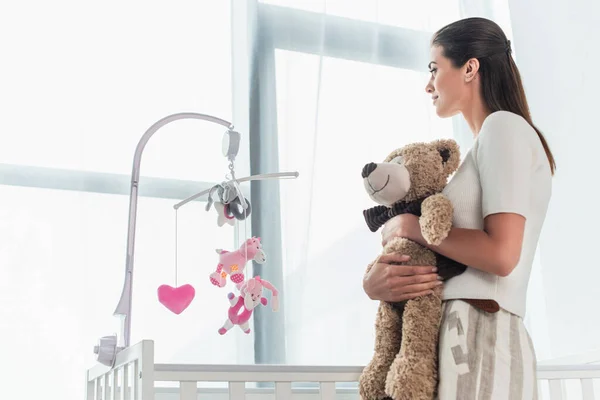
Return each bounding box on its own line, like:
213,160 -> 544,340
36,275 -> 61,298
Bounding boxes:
363,254 -> 442,302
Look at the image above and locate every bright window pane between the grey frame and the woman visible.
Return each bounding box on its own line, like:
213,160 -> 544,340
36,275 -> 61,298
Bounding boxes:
276,51 -> 452,365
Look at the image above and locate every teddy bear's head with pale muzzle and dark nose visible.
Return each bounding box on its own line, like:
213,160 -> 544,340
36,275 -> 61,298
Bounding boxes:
362,139 -> 460,207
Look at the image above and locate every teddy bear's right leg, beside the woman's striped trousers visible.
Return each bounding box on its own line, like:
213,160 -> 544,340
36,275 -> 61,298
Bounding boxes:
386,286 -> 442,400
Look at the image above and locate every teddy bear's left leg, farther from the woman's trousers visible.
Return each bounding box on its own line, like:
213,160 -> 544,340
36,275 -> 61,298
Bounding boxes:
359,301 -> 402,400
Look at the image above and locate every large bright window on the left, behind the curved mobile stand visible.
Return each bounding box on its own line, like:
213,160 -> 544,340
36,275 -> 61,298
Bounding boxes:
0,0 -> 253,400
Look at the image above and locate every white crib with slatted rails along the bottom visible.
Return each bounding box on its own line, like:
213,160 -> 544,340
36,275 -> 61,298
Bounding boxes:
86,340 -> 600,400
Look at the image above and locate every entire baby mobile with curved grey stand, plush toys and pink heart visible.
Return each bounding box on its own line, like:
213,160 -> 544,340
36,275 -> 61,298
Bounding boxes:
89,112 -> 298,366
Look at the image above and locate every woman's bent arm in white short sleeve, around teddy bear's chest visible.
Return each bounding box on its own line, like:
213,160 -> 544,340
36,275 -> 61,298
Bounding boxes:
389,112 -> 545,276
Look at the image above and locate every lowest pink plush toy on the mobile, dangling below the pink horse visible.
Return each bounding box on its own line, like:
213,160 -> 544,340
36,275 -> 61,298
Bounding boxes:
219,276 -> 279,335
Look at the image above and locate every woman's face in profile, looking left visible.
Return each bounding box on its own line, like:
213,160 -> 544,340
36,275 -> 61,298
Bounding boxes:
425,46 -> 470,118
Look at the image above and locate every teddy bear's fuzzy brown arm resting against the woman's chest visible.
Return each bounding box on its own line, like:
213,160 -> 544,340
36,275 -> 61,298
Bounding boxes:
419,193 -> 454,246
